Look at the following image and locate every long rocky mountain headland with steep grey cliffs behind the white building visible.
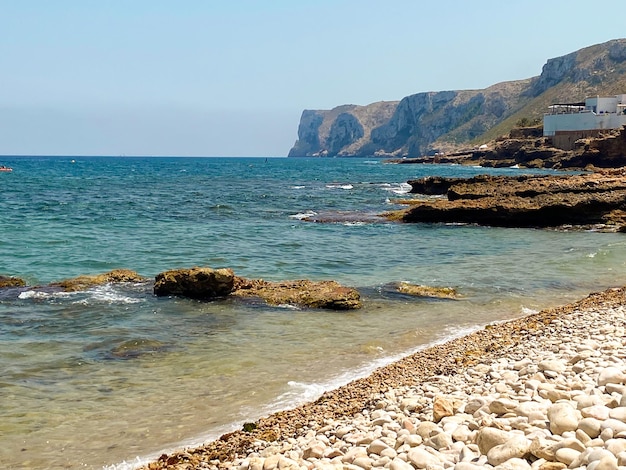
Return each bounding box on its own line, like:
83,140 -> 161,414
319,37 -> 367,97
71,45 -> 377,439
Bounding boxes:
289,39 -> 626,157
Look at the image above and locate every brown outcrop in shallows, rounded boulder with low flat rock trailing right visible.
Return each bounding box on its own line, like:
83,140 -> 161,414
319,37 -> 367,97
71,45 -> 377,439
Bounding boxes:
154,267 -> 361,310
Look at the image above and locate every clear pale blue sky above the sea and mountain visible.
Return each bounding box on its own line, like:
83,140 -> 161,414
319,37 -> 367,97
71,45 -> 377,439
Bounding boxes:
0,0 -> 626,156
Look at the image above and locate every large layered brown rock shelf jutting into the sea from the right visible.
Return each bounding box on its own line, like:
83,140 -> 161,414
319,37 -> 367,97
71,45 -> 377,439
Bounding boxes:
388,169 -> 626,231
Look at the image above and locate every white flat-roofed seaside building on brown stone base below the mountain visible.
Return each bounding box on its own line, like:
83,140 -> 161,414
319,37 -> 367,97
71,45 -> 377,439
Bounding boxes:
543,94 -> 626,150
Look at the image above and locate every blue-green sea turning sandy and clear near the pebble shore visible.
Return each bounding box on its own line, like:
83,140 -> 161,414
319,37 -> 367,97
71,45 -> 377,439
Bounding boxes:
0,156 -> 626,470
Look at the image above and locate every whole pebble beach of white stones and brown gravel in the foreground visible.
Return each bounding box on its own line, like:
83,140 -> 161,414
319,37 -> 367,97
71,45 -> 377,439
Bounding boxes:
142,288 -> 626,470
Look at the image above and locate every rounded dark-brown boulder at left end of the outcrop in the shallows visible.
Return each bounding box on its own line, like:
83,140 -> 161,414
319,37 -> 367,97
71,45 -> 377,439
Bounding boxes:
154,267 -> 235,300
